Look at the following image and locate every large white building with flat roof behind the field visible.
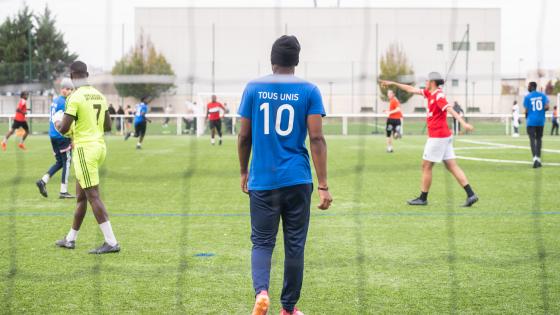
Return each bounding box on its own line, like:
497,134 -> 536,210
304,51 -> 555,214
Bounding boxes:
135,8 -> 498,113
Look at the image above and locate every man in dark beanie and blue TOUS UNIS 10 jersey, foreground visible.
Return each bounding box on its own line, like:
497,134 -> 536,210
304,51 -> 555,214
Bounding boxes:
238,36 -> 332,315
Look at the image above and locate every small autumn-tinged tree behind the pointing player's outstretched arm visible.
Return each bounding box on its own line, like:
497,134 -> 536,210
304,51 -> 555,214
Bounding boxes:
379,44 -> 414,103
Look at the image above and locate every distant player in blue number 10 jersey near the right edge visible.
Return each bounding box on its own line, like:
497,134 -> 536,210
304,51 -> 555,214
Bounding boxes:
523,82 -> 549,168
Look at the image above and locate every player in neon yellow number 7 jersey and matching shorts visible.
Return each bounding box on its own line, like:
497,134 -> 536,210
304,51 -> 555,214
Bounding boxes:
55,61 -> 121,254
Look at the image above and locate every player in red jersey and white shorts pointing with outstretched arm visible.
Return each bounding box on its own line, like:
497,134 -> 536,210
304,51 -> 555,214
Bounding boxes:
380,72 -> 478,207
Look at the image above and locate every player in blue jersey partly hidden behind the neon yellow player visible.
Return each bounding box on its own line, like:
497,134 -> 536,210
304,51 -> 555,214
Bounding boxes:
35,78 -> 75,199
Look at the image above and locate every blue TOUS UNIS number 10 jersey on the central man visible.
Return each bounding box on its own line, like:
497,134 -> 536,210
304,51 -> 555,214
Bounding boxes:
239,75 -> 325,190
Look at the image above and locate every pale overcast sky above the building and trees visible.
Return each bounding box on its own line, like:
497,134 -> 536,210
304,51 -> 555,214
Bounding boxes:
0,0 -> 560,75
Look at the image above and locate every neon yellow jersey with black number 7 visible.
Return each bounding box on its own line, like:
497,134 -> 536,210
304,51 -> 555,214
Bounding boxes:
65,85 -> 108,144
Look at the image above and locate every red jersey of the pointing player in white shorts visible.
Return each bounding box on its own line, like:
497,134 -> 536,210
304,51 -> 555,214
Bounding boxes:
423,89 -> 451,138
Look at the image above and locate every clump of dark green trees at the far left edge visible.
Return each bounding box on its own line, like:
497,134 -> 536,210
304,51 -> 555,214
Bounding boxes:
0,6 -> 76,85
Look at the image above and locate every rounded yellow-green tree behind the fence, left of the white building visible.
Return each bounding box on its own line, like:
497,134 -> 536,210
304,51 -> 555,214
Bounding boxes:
112,35 -> 175,99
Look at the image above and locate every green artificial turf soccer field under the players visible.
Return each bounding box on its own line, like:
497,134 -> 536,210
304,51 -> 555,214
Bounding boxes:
0,136 -> 560,315
